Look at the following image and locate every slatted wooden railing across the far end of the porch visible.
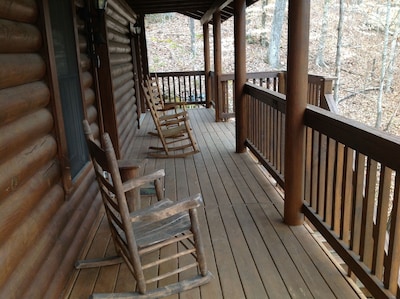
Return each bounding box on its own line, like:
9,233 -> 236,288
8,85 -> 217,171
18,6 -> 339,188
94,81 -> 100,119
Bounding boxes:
150,71 -> 337,121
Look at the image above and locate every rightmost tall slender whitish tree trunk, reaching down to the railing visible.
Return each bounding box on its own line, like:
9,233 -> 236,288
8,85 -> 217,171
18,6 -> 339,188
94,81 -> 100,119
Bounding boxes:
375,0 -> 391,128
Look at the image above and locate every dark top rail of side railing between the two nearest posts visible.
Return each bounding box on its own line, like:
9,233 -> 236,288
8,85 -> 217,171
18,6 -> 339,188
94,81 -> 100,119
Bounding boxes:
244,83 -> 286,113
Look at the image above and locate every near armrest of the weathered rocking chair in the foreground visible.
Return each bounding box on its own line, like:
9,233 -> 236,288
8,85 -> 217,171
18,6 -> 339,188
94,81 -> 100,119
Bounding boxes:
131,193 -> 203,222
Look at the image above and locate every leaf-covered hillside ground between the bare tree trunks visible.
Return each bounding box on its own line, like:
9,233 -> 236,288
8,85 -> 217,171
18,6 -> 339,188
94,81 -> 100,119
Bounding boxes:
146,0 -> 400,136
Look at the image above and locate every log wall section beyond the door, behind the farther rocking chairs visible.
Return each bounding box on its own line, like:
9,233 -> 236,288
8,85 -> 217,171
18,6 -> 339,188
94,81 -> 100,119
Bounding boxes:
106,1 -> 138,157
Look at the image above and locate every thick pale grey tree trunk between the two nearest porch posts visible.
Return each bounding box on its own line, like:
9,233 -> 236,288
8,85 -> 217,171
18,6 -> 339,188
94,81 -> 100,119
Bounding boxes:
268,0 -> 287,68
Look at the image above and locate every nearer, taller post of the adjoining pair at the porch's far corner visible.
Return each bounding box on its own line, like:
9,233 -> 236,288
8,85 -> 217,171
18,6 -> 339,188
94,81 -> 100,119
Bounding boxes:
213,11 -> 222,122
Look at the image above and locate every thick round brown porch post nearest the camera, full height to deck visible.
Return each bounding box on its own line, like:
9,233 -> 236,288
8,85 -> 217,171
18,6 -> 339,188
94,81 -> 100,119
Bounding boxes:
284,0 -> 310,225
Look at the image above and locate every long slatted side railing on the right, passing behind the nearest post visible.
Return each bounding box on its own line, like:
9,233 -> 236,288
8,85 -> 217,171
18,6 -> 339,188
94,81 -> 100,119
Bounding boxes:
245,84 -> 400,298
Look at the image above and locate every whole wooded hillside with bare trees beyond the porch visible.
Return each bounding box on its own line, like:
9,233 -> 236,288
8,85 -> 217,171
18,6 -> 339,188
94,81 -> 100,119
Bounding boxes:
146,0 -> 400,136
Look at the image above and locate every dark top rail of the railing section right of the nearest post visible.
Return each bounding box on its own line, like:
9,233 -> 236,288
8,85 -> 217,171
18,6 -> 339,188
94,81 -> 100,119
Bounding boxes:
304,105 -> 400,171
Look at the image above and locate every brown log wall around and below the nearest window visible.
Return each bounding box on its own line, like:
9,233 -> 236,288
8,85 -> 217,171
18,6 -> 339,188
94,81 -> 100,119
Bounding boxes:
0,0 -> 100,299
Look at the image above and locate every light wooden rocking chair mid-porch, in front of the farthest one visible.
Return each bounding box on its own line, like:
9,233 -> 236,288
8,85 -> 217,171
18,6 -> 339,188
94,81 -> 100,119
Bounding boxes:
142,82 -> 199,158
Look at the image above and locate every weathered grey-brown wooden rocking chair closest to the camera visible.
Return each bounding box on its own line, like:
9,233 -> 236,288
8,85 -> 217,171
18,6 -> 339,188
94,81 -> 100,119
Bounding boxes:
76,121 -> 212,298
